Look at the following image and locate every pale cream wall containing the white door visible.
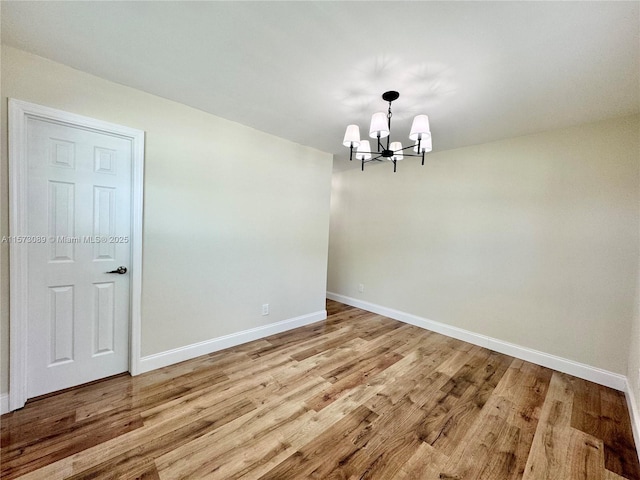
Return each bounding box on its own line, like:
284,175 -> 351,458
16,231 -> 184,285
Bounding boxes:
0,46 -> 332,392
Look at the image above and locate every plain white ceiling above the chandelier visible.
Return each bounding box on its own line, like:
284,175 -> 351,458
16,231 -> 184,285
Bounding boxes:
1,1 -> 640,170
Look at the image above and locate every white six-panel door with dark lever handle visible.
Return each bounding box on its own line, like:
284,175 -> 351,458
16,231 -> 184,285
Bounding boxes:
23,118 -> 132,398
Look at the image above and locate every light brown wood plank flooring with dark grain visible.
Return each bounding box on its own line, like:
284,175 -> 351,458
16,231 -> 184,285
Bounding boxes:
0,301 -> 640,480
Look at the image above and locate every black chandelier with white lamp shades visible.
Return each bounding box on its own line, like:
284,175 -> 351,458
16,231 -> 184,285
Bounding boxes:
342,90 -> 432,172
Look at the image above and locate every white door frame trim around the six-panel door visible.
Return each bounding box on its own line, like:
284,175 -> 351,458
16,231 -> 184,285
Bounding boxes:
9,98 -> 144,411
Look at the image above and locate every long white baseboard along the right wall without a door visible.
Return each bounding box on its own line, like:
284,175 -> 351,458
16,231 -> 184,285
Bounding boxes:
327,292 -> 627,392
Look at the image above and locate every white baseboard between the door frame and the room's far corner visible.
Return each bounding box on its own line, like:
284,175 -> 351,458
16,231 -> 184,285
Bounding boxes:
138,310 -> 327,373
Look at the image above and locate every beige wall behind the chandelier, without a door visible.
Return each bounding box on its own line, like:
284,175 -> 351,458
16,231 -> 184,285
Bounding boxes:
328,116 -> 640,375
